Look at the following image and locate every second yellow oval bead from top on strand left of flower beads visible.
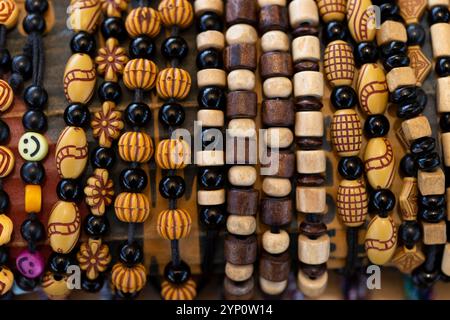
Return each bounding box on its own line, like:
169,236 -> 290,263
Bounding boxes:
63,53 -> 97,104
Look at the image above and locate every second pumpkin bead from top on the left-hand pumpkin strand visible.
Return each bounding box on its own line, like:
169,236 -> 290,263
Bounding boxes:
123,59 -> 158,90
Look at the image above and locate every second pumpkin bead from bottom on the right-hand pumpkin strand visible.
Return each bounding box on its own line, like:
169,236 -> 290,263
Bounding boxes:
156,209 -> 192,240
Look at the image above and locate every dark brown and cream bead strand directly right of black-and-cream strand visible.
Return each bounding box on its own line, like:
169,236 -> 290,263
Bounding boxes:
224,0 -> 259,300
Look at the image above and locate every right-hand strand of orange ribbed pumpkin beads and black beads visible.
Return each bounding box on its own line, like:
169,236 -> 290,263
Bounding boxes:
156,0 -> 197,300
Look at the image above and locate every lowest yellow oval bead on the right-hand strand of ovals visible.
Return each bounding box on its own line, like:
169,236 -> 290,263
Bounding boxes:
364,215 -> 397,265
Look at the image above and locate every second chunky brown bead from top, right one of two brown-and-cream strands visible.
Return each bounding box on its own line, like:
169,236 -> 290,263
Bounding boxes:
260,52 -> 292,79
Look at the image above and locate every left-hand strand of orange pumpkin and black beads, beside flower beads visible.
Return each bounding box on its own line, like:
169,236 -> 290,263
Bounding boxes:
111,3 -> 161,299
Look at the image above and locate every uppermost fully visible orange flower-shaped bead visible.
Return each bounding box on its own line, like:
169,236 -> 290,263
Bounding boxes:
95,38 -> 128,82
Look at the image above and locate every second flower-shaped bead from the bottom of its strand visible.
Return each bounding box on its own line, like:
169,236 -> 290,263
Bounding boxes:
84,169 -> 114,216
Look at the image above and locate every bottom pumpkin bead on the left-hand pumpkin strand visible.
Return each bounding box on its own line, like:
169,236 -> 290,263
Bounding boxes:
111,263 -> 147,293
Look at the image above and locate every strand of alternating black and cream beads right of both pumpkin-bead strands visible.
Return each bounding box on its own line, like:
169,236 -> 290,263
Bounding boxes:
194,0 -> 227,281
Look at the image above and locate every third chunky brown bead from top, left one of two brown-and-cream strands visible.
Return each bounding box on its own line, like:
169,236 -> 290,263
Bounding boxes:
227,91 -> 258,119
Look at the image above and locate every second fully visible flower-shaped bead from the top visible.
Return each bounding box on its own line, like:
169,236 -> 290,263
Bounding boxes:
91,101 -> 123,148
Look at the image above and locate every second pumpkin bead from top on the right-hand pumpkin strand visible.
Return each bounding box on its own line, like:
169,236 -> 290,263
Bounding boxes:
156,68 -> 192,100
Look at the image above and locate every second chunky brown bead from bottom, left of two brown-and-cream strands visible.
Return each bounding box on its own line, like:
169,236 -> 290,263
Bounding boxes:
224,234 -> 258,265
